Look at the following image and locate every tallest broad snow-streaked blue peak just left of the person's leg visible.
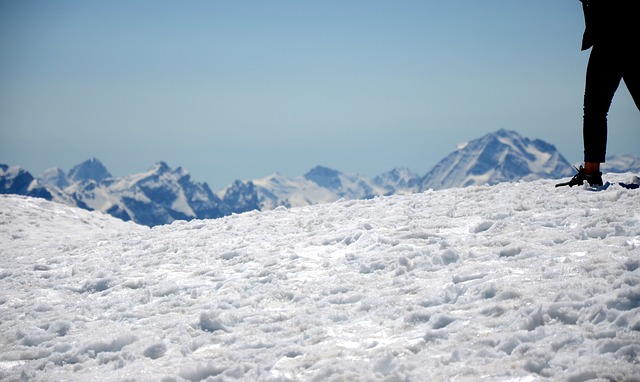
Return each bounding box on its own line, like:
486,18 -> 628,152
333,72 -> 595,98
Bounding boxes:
420,130 -> 573,190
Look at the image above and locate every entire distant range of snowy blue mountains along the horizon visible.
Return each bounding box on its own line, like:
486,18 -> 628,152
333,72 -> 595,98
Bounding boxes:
0,130 -> 640,226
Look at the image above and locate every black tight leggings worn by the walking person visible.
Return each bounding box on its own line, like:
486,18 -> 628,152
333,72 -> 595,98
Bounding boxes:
582,42 -> 640,163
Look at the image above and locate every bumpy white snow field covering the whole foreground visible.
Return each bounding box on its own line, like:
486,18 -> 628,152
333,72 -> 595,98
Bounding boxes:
0,174 -> 640,382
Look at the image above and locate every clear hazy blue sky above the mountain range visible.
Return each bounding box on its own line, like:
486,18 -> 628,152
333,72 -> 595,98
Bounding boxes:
0,0 -> 640,190
